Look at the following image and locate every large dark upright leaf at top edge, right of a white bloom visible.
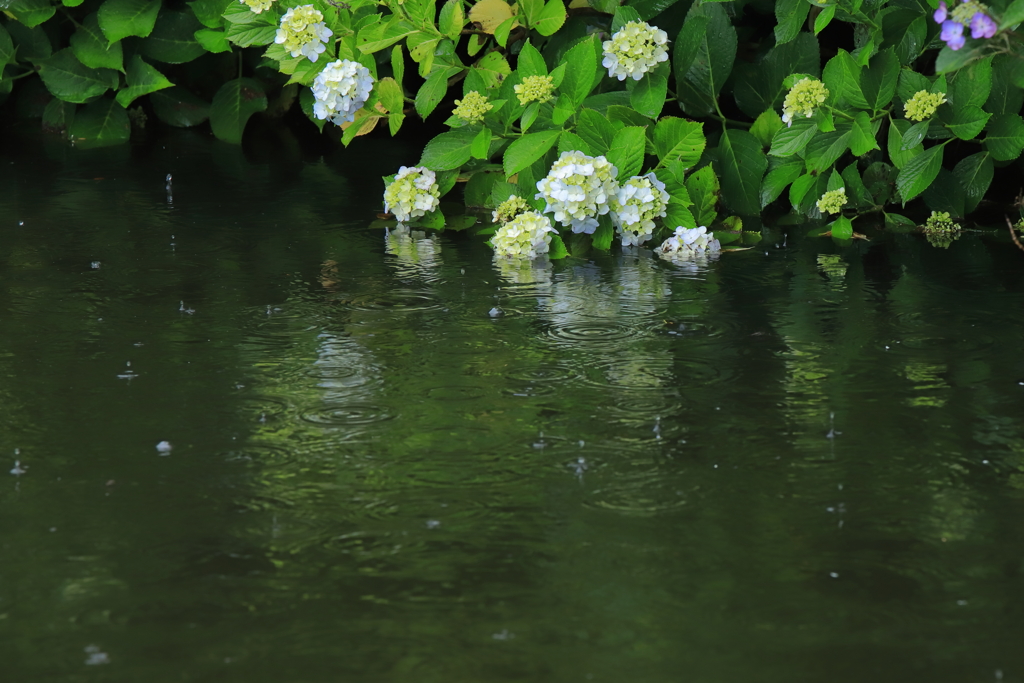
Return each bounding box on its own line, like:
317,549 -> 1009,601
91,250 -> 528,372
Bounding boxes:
676,4 -> 737,117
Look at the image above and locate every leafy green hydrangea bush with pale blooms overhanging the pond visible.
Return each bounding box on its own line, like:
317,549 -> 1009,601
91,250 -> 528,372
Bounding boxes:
6,0 -> 1024,253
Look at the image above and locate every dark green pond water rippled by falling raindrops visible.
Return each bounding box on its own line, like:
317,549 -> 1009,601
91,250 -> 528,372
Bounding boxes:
0,129 -> 1024,683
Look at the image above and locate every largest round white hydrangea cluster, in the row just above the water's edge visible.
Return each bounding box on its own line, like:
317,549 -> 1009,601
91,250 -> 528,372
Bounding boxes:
535,152 -> 618,234
